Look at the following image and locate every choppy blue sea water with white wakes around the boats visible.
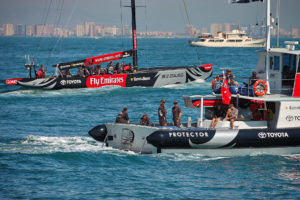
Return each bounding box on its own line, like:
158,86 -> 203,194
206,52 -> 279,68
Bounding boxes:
0,37 -> 300,199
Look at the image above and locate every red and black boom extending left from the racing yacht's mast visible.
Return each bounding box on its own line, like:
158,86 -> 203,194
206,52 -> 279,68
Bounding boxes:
53,50 -> 132,70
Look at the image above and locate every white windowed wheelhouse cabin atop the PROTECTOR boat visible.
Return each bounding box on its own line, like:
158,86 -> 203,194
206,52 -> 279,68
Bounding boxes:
256,41 -> 300,97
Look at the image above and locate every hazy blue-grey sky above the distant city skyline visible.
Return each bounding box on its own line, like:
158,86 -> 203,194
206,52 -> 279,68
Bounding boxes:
0,0 -> 300,32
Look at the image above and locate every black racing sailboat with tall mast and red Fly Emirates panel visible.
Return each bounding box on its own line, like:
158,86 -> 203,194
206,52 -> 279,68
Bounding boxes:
5,0 -> 212,89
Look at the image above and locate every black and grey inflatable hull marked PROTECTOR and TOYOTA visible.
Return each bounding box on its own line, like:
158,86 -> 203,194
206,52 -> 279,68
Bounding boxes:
89,123 -> 300,156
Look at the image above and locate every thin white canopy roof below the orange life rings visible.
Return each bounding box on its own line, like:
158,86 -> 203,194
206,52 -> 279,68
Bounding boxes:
183,94 -> 300,102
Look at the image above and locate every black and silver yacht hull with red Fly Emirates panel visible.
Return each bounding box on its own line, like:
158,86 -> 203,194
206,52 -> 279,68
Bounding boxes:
13,64 -> 212,89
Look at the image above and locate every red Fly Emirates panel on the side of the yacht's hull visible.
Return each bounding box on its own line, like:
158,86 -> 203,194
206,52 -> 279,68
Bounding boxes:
86,74 -> 127,87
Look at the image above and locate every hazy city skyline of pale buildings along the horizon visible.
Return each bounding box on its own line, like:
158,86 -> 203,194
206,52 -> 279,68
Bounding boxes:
0,22 -> 300,38
